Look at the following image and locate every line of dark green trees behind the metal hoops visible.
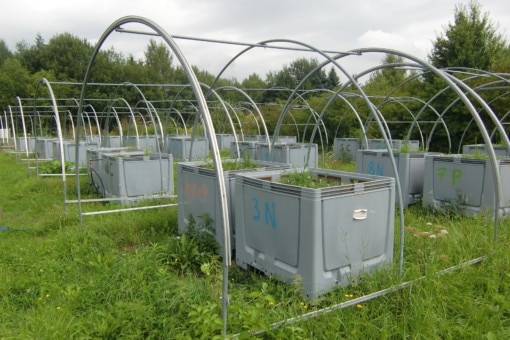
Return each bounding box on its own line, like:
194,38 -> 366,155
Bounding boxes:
0,2 -> 510,149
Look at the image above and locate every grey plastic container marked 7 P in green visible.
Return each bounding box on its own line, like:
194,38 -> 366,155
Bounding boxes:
423,155 -> 510,216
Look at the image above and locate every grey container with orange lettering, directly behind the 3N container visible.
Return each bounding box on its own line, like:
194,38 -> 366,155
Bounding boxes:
177,159 -> 289,249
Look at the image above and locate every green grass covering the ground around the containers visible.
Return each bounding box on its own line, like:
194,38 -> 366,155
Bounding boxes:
0,152 -> 510,339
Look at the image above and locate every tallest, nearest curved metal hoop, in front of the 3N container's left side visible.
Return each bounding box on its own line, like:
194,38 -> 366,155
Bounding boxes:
76,16 -> 231,335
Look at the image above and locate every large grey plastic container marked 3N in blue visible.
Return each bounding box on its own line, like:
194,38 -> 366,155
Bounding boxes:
235,169 -> 395,298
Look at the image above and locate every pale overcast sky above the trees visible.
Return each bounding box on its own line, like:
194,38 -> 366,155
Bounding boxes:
0,0 -> 510,81
